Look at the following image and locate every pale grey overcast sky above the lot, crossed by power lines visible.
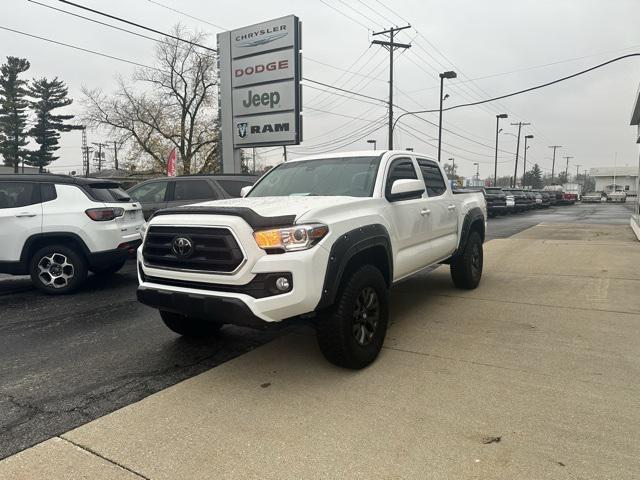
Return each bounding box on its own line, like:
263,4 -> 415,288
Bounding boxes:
0,0 -> 640,177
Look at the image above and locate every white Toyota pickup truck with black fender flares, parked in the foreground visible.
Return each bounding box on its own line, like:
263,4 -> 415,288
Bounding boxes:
138,151 -> 487,368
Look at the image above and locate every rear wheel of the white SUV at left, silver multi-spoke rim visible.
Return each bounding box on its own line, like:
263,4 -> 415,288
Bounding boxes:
29,245 -> 87,295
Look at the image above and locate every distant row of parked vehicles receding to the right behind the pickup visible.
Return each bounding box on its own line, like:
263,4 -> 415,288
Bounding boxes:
457,187 -> 575,217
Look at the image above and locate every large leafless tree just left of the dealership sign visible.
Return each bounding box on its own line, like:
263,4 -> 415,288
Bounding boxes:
83,25 -> 219,174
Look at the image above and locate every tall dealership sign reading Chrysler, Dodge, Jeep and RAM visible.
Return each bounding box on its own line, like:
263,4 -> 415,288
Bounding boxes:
218,15 -> 302,152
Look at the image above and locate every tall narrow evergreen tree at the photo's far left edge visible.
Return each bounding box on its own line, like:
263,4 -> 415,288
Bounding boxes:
0,57 -> 30,173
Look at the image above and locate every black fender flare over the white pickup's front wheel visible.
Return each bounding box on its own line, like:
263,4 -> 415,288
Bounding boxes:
316,224 -> 393,310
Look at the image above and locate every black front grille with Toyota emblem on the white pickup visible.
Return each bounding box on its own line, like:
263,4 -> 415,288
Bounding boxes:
142,226 -> 244,273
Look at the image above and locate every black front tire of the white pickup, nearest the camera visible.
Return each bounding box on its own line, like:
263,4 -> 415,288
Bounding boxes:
316,265 -> 389,370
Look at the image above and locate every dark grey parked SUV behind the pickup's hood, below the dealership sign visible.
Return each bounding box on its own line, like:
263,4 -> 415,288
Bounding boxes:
127,175 -> 259,220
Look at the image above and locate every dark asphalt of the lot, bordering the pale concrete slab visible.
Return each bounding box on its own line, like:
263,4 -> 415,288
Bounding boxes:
0,204 -> 631,458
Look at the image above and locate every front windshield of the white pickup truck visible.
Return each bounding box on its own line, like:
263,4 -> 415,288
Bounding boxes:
247,156 -> 380,197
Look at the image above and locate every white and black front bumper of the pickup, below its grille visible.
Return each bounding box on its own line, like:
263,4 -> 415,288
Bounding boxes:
137,232 -> 329,327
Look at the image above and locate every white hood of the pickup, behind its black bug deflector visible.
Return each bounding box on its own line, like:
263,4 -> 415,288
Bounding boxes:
188,195 -> 363,218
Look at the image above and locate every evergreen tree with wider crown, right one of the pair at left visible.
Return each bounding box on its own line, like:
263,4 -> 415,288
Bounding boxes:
27,77 -> 82,172
